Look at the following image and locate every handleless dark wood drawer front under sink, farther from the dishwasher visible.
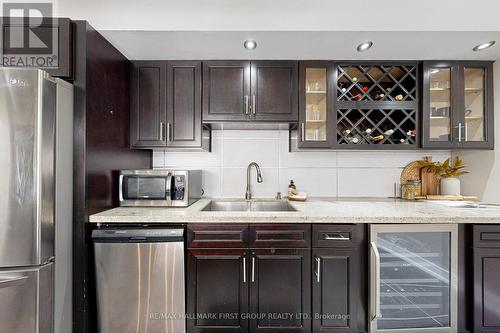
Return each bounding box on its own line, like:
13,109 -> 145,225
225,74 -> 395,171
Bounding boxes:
249,224 -> 311,248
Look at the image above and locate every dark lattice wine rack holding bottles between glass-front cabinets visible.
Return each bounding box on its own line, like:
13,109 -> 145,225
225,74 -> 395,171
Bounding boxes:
335,63 -> 419,149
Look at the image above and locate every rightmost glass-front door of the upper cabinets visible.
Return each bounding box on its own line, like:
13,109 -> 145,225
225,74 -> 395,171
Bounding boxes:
459,62 -> 493,148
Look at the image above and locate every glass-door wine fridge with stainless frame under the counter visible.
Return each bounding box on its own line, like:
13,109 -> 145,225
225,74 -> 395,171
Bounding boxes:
369,224 -> 458,333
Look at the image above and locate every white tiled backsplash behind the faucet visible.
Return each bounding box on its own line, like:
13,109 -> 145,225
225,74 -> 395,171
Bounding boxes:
153,130 -> 450,197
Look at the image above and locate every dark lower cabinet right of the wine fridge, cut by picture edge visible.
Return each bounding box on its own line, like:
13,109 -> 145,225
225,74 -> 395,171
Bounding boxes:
473,225 -> 500,333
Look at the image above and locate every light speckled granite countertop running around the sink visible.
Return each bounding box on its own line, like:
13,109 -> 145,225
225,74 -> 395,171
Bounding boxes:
90,198 -> 500,224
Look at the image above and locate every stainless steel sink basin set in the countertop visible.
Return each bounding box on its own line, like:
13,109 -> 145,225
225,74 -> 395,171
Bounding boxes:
202,200 -> 296,212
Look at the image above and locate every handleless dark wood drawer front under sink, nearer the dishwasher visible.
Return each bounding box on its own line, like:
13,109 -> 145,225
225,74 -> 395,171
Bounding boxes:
187,224 -> 248,248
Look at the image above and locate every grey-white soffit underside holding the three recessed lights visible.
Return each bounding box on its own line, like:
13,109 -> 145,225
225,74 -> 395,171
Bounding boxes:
101,31 -> 500,60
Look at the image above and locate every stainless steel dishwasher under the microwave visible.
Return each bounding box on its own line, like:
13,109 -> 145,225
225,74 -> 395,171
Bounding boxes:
92,228 -> 186,333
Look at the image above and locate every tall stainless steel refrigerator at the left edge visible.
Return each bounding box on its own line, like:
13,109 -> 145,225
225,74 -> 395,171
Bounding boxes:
0,68 -> 73,333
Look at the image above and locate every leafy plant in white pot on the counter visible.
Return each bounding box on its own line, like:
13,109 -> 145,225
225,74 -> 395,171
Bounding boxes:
420,156 -> 467,195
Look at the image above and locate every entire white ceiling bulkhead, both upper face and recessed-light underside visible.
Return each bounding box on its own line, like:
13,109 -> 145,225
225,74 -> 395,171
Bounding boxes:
55,0 -> 500,60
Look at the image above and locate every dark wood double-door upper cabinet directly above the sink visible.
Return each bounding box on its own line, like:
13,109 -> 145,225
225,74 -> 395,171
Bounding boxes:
203,61 -> 298,122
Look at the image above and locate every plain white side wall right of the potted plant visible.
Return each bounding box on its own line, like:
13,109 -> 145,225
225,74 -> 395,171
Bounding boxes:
454,62 -> 500,204
